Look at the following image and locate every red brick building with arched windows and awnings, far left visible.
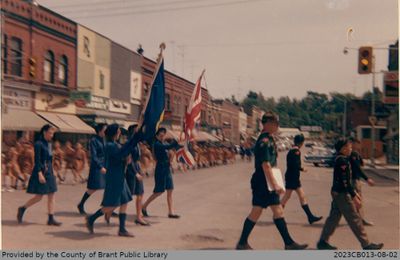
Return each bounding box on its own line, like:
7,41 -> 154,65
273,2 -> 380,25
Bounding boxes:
1,0 -> 92,148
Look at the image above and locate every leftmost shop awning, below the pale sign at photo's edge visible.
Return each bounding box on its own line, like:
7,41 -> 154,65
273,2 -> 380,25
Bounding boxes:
1,109 -> 47,131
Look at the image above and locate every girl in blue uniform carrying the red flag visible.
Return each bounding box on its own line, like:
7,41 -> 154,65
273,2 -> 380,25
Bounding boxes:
142,127 -> 180,218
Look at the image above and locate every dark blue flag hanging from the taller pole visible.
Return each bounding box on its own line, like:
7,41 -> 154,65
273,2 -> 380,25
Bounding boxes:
142,58 -> 165,143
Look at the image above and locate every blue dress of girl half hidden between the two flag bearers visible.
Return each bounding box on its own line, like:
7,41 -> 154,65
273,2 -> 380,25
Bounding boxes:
126,145 -> 144,195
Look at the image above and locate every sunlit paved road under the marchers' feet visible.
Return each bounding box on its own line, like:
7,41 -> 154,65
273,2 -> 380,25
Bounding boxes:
2,154 -> 399,250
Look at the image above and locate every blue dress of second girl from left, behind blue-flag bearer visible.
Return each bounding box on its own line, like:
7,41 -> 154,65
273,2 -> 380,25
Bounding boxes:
87,135 -> 106,190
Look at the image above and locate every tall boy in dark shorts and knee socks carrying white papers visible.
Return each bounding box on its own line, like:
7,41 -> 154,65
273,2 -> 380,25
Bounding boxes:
236,113 -> 308,250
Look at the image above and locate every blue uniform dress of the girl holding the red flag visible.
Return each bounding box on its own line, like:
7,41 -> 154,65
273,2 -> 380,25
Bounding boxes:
153,140 -> 180,193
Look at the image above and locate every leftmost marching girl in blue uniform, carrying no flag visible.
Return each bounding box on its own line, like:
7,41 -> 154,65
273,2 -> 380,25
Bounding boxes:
17,124 -> 61,226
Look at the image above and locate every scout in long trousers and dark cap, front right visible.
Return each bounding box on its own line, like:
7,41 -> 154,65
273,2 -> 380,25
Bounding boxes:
317,138 -> 383,250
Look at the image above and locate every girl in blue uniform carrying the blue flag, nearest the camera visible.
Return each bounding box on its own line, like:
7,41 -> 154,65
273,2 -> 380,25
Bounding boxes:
86,124 -> 140,237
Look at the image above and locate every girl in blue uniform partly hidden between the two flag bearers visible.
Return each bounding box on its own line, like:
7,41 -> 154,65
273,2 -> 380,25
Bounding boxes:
126,125 -> 150,226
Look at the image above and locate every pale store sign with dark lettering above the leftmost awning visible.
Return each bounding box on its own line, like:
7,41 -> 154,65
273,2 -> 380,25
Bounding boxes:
3,88 -> 32,110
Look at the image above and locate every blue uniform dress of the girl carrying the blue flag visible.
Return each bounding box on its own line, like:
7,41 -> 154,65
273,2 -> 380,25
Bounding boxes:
101,138 -> 138,207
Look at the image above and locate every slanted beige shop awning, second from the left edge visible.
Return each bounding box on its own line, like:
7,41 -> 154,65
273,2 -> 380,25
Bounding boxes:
37,112 -> 95,134
